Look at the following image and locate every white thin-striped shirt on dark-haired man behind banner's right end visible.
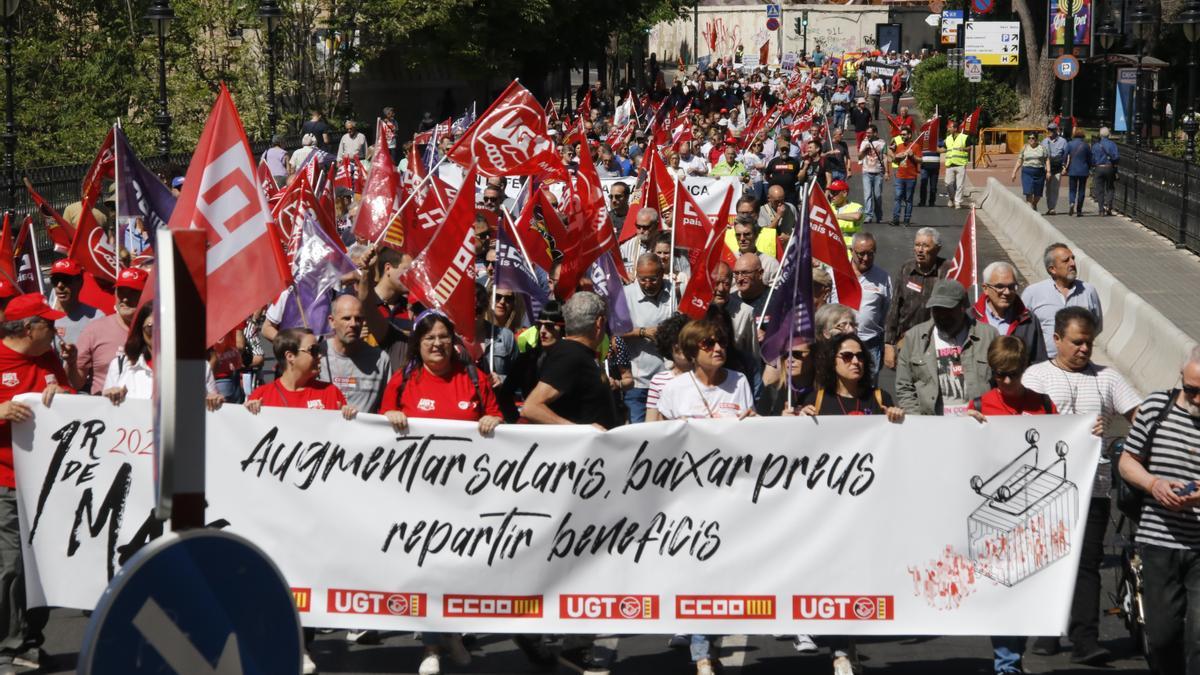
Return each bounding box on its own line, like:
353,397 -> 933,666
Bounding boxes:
1021,360 -> 1141,498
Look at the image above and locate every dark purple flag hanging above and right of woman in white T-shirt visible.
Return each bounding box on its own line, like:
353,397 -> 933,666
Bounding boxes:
762,182 -> 814,362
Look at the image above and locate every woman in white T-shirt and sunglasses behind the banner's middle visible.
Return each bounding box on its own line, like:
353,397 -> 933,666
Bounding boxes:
658,318 -> 754,419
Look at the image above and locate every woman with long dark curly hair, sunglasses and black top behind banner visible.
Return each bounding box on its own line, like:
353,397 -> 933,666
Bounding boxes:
785,333 -> 904,422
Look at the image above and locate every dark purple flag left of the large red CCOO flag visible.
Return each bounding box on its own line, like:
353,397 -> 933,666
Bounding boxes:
113,127 -> 175,256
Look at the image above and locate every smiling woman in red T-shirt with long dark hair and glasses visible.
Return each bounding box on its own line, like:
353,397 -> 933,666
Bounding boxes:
379,310 -> 503,435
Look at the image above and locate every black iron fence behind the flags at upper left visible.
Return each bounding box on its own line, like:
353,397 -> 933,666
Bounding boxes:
0,137 -> 300,254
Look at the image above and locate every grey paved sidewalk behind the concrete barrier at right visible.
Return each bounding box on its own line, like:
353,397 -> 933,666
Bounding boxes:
968,155 -> 1200,341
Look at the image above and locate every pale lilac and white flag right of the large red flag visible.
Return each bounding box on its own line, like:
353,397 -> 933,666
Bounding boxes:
280,209 -> 355,335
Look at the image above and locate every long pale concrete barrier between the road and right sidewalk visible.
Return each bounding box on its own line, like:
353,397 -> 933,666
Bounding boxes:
980,178 -> 1196,393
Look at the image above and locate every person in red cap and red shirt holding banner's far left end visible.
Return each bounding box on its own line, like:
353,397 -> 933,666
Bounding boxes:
0,293 -> 74,669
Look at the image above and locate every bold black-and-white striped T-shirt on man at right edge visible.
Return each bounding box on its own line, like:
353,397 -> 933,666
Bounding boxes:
1124,392 -> 1200,550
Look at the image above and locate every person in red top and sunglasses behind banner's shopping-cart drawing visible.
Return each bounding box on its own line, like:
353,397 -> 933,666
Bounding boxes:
966,335 -> 1058,674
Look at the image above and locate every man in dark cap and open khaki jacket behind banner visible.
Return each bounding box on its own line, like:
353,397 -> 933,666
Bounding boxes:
896,279 -> 996,417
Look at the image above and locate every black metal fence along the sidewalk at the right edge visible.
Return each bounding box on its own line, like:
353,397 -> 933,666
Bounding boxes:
1112,143 -> 1200,253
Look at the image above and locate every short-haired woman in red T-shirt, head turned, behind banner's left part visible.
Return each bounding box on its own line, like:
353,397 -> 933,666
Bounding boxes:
246,328 -> 359,419
